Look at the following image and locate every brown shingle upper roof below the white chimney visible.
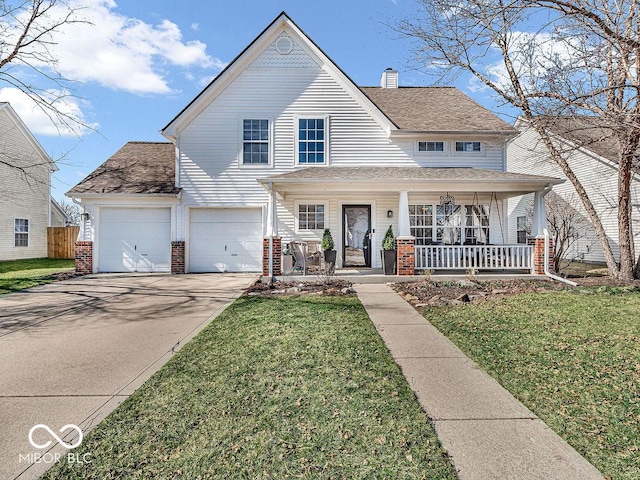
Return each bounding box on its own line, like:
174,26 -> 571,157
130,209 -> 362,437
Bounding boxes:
361,87 -> 516,133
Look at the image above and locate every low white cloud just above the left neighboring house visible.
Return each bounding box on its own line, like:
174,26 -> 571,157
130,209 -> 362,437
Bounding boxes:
0,87 -> 98,137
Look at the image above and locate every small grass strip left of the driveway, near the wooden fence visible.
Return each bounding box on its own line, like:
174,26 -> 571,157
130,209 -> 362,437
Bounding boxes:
0,258 -> 74,295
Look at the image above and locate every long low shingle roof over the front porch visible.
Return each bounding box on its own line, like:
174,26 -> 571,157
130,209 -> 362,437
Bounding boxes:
262,167 -> 562,183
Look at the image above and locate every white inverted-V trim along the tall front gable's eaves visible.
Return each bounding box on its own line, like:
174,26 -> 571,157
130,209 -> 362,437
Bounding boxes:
160,11 -> 397,140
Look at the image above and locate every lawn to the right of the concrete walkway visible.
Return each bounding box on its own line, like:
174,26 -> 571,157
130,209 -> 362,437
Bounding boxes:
423,287 -> 640,480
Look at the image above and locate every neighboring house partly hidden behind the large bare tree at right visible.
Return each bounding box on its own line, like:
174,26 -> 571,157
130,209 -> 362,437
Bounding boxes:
507,116 -> 640,263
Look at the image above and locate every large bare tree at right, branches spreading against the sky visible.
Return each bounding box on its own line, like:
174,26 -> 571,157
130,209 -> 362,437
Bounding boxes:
394,0 -> 640,280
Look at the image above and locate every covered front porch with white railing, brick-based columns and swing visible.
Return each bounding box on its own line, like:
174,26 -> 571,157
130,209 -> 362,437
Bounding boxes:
261,167 -> 562,276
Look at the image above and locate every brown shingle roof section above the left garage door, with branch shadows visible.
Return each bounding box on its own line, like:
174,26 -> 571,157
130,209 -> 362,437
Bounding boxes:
66,142 -> 180,196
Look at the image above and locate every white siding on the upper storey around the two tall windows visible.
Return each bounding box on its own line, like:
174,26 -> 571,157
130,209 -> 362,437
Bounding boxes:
174,31 -> 504,210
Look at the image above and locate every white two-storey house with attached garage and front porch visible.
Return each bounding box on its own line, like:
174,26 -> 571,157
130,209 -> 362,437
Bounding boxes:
67,12 -> 560,275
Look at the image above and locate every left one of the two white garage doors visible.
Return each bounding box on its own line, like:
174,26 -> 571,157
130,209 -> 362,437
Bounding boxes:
98,208 -> 171,272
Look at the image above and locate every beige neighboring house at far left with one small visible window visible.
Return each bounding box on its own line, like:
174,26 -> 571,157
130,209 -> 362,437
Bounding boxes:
0,103 -> 58,260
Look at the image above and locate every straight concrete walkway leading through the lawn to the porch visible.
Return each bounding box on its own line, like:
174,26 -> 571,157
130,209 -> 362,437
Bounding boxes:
354,284 -> 603,480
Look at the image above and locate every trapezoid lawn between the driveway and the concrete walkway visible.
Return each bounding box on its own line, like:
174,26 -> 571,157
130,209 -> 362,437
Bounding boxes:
45,296 -> 455,479
